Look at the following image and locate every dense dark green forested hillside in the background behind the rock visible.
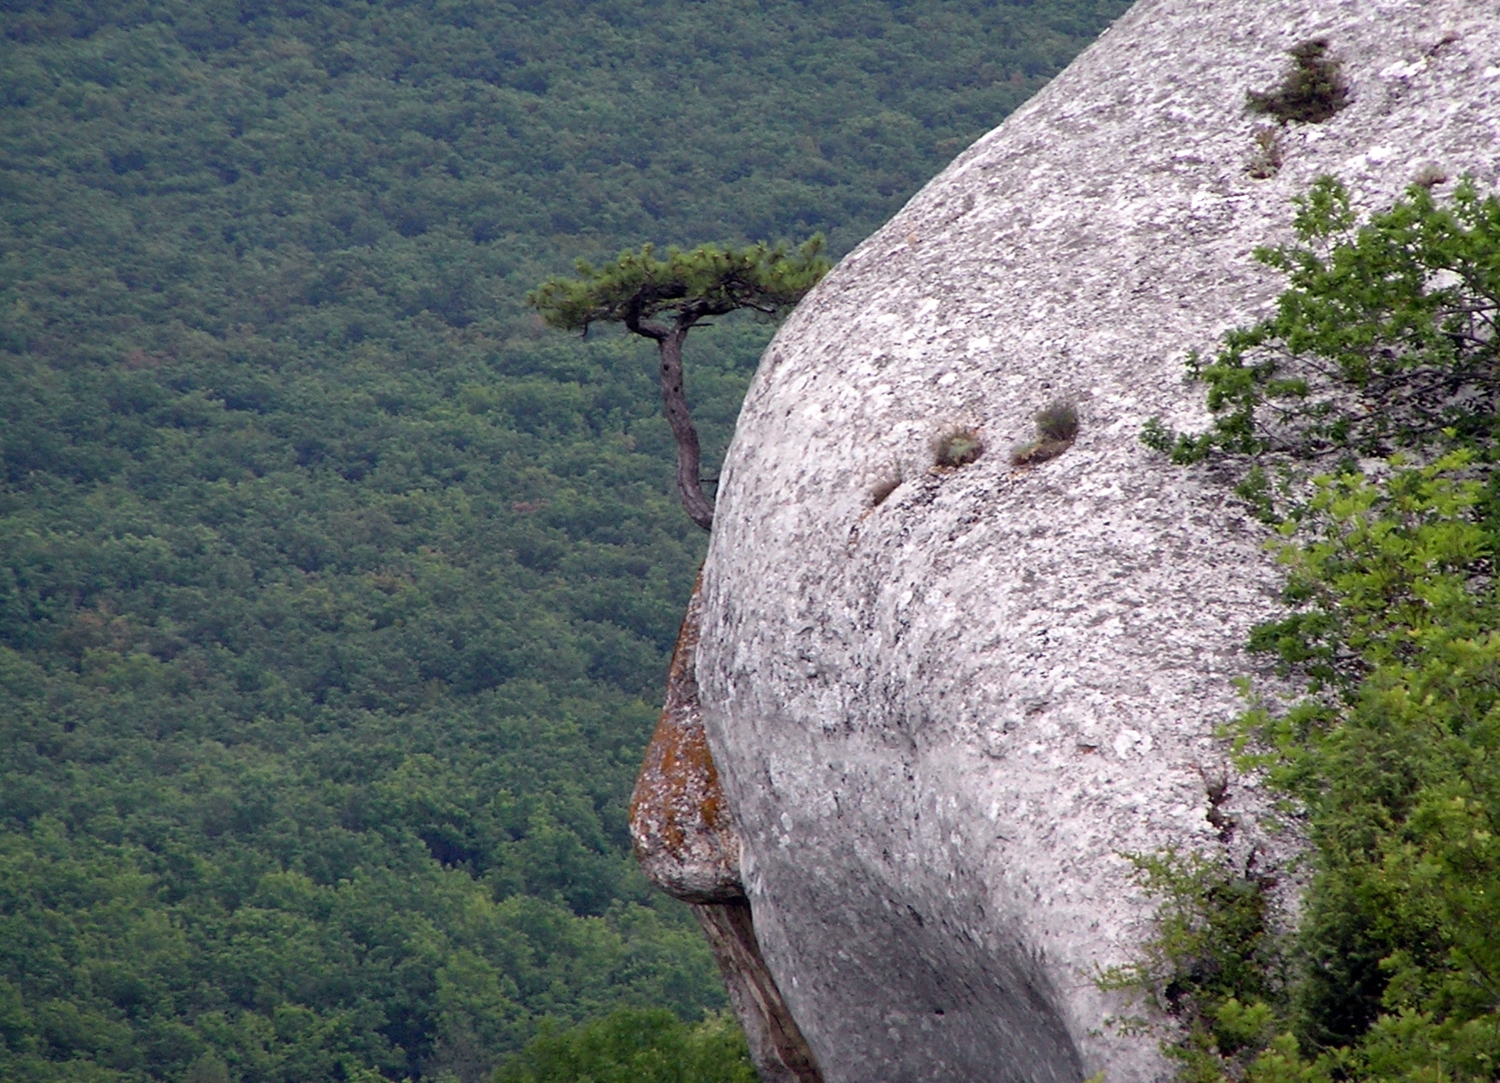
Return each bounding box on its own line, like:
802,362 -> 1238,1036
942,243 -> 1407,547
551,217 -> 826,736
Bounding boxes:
0,0 -> 1127,1083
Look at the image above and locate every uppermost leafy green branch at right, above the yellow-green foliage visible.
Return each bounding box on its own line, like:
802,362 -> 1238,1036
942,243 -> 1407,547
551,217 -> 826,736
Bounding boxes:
1142,177 -> 1500,498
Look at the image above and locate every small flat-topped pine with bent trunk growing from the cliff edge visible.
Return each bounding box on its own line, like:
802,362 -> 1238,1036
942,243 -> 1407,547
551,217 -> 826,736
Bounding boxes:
527,234 -> 831,530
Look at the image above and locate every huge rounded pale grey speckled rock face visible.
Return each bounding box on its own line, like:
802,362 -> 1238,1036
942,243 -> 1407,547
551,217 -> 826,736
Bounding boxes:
698,0 -> 1500,1083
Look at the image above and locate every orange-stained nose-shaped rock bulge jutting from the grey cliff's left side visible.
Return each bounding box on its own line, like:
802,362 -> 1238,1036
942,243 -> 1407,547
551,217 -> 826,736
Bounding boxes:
630,579 -> 744,903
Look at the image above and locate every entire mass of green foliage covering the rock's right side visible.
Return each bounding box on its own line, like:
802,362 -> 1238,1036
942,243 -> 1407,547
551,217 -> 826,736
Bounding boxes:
1128,177 -> 1500,1083
